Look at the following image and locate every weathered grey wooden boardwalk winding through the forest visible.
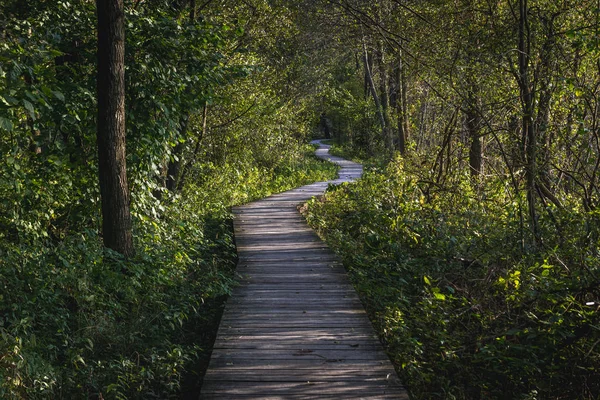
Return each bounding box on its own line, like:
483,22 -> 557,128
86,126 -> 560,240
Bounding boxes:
200,141 -> 408,399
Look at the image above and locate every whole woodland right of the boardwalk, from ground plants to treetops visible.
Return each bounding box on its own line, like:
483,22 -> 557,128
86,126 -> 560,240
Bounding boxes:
300,0 -> 600,399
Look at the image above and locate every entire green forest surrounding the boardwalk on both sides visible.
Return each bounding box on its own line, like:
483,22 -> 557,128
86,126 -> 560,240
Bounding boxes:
0,0 -> 600,399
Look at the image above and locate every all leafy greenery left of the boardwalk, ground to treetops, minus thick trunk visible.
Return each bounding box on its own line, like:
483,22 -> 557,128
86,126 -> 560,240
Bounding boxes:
0,0 -> 335,399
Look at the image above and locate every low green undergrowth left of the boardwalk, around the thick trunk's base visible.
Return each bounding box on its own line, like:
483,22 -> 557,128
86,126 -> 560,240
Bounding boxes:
0,146 -> 337,399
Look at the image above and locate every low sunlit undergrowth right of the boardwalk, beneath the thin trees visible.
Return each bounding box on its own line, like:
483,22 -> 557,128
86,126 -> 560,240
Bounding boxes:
305,153 -> 600,399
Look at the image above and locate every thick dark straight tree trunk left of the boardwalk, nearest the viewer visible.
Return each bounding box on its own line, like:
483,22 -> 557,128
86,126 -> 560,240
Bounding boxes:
96,0 -> 134,257
